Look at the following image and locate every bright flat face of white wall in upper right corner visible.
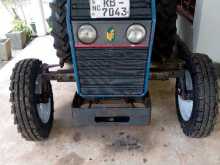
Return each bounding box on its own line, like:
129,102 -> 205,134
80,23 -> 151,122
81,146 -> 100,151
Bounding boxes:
195,0 -> 220,62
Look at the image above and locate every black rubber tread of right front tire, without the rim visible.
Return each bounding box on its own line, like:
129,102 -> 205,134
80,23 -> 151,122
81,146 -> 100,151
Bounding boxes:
178,54 -> 218,138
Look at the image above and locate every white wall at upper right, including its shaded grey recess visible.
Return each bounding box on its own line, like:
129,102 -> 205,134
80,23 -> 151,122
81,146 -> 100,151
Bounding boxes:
177,0 -> 220,62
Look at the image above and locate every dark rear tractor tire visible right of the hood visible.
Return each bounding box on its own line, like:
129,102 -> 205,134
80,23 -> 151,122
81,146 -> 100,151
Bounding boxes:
153,0 -> 177,61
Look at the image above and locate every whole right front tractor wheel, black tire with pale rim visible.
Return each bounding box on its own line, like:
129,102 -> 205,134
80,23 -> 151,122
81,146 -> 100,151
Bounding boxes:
176,54 -> 218,138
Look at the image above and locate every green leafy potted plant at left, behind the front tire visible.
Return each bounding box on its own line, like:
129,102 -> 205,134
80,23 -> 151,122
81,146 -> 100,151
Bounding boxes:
12,19 -> 32,41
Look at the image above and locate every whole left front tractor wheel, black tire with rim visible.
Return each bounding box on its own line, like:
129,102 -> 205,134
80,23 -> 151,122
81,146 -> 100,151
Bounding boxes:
10,59 -> 54,141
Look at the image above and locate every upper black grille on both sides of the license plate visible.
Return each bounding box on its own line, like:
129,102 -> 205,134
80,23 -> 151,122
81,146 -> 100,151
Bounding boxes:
72,0 -> 151,20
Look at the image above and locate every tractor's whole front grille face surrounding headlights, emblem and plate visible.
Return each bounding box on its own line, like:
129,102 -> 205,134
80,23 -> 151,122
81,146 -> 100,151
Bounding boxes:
71,0 -> 152,97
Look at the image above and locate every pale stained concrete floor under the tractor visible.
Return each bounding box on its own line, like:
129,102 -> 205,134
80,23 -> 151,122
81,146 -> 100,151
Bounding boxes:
0,37 -> 220,165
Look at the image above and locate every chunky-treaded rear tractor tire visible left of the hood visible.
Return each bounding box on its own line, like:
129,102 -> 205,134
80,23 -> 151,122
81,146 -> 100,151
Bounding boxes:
50,0 -> 71,65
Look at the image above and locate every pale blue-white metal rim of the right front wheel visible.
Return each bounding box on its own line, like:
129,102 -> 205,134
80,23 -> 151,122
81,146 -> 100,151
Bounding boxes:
177,71 -> 194,121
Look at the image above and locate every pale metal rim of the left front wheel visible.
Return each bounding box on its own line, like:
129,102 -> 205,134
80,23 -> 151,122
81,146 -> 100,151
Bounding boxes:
35,78 -> 52,124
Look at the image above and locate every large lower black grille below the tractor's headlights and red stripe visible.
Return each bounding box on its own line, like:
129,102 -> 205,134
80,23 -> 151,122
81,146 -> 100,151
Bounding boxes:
76,48 -> 150,96
